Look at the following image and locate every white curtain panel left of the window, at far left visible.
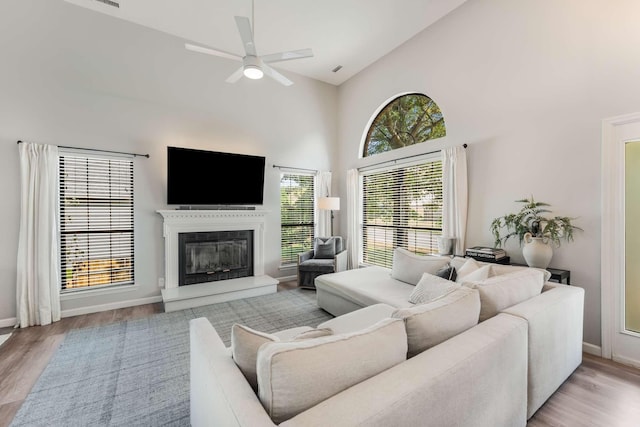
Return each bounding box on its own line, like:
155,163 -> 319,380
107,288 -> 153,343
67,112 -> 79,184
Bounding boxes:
16,142 -> 60,328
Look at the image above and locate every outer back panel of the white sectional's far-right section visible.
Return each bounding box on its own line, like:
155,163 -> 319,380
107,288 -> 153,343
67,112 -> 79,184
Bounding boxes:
503,284 -> 584,419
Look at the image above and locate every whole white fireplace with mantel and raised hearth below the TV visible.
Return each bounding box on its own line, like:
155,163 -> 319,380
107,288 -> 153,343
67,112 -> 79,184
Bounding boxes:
158,209 -> 278,311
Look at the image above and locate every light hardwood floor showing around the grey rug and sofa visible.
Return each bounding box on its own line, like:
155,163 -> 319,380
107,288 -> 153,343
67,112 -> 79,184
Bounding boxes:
0,282 -> 640,427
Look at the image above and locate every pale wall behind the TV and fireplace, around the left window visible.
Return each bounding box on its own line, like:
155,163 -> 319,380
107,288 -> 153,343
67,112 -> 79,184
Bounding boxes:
0,0 -> 337,322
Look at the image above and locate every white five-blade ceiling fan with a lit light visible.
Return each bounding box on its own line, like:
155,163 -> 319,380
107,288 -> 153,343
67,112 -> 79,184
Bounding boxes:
184,2 -> 313,86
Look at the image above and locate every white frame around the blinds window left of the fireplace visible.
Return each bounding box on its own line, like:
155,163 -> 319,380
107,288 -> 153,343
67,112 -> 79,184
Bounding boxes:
57,148 -> 137,299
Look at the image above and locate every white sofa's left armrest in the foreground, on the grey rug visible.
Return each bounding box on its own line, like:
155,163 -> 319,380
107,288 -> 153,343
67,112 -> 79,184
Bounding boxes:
189,317 -> 275,427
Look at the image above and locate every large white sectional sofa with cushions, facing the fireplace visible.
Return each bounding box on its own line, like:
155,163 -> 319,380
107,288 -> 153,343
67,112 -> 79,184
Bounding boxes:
190,252 -> 584,427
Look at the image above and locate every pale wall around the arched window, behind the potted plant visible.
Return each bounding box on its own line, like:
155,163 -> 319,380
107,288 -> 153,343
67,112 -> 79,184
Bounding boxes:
335,0 -> 640,345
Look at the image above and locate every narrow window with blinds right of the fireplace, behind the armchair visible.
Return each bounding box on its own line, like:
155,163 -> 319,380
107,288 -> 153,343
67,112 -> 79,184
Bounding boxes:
280,173 -> 315,265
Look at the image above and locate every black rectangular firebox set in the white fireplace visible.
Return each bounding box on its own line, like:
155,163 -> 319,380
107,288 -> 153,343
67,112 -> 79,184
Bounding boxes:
178,230 -> 253,286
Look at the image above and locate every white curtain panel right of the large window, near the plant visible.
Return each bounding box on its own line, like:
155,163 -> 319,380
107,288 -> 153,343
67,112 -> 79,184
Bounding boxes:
442,146 -> 468,255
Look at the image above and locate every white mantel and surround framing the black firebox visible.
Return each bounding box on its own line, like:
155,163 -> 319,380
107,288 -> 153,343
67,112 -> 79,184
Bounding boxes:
157,209 -> 268,289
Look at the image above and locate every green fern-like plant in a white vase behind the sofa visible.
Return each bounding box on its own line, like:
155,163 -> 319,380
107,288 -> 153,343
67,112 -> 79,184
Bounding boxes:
491,196 -> 582,268
